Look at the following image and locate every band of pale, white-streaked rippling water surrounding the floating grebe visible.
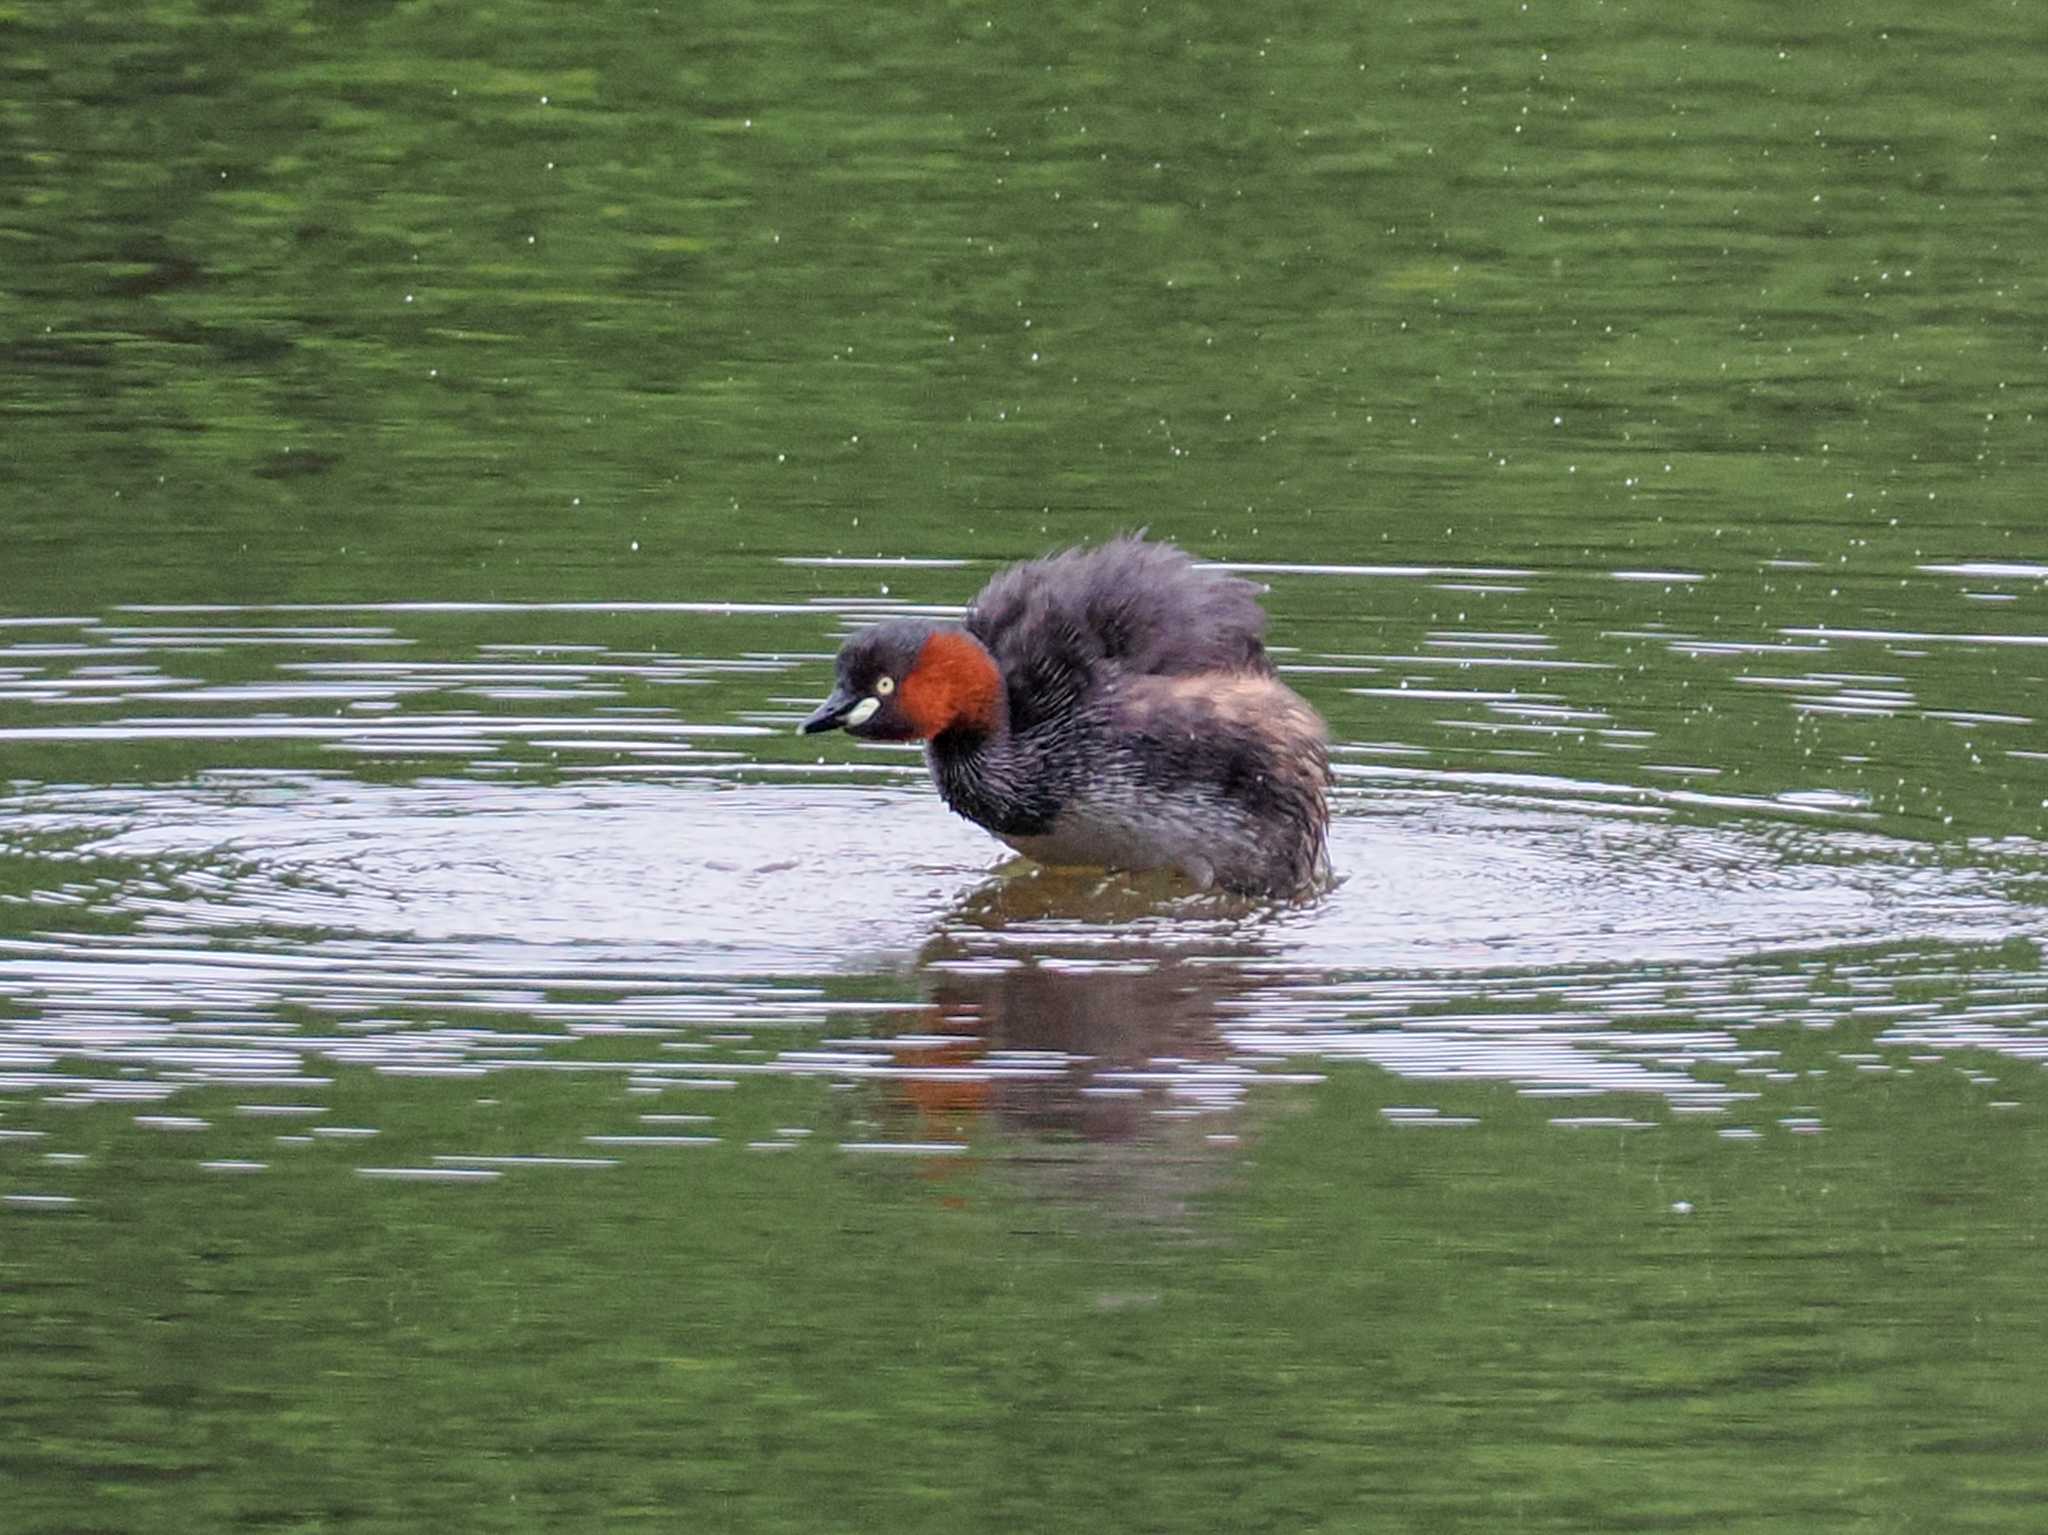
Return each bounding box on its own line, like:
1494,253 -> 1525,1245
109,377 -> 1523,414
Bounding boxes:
0,577 -> 2048,1208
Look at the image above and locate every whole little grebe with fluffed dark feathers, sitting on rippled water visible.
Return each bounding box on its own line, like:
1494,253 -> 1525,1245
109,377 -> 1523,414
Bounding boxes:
801,538 -> 1329,896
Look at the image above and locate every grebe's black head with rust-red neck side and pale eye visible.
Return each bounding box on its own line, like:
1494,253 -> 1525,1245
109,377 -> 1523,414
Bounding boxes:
799,618 -> 1004,741
